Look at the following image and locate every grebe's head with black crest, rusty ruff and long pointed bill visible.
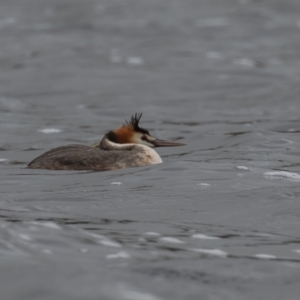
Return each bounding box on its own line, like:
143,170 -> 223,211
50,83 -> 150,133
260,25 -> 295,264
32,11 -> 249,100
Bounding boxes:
106,113 -> 185,148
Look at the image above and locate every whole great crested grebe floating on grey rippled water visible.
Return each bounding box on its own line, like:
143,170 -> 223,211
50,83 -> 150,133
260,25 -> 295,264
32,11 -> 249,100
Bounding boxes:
27,113 -> 185,171
